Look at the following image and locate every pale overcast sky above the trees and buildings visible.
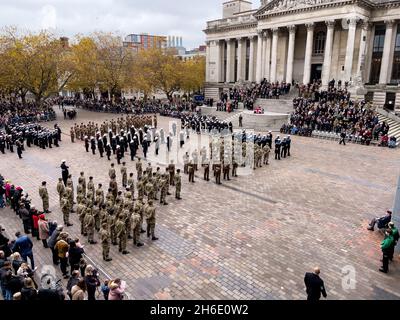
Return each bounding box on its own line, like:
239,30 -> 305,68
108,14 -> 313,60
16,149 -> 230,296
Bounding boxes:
0,0 -> 259,49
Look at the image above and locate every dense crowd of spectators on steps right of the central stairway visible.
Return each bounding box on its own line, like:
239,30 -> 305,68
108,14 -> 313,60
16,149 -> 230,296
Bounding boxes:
281,83 -> 396,146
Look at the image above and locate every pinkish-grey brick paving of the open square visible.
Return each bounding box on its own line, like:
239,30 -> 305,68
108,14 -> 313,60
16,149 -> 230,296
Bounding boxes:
0,108 -> 400,299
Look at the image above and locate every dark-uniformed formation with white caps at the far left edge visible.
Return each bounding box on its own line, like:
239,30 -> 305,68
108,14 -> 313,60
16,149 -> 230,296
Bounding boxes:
0,123 -> 61,158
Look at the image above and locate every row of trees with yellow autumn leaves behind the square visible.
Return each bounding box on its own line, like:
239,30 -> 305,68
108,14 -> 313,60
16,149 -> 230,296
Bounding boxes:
0,29 -> 205,104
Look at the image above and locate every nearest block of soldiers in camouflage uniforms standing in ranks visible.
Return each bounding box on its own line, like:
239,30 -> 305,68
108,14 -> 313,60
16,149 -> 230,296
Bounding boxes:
54,159 -> 182,261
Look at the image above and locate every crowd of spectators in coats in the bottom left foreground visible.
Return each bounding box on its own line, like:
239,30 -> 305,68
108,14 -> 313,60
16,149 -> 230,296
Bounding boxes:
0,176 -> 125,301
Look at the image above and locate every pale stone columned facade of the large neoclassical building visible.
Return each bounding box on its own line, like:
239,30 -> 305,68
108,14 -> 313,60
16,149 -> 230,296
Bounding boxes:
204,0 -> 400,109
